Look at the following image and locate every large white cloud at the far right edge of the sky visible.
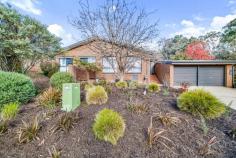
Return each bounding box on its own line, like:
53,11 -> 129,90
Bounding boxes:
211,14 -> 236,31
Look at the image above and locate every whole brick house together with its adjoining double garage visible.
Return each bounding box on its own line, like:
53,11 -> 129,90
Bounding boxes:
52,40 -> 236,87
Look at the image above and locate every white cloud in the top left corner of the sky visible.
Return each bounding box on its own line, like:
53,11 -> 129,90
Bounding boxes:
0,0 -> 42,15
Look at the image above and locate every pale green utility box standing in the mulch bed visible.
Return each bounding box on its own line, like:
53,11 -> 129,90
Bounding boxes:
62,83 -> 80,112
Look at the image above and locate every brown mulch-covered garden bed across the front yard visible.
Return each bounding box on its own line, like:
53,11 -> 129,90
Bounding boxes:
0,89 -> 236,158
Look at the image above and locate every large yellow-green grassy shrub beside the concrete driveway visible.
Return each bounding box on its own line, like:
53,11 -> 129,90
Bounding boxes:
177,89 -> 225,119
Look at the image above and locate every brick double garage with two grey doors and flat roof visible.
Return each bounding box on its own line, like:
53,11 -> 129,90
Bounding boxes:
155,60 -> 236,87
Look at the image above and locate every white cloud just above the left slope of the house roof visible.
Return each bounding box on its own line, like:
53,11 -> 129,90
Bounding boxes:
47,24 -> 76,46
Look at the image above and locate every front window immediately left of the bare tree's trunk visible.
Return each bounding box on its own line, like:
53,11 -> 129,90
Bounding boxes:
102,57 -> 117,73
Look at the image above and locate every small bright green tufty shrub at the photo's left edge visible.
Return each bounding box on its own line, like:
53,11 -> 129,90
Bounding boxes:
1,102 -> 19,121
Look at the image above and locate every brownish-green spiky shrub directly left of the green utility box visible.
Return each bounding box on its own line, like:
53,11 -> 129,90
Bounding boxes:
38,87 -> 61,108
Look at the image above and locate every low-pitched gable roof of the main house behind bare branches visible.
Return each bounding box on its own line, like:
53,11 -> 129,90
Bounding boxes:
59,37 -> 162,59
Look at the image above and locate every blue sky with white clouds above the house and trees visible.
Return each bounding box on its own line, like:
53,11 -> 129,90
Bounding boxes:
0,0 -> 236,46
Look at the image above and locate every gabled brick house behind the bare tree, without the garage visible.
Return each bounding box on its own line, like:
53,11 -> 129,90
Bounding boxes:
56,40 -> 158,83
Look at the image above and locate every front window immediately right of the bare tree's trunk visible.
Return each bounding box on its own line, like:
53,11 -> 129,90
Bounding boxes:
127,57 -> 142,73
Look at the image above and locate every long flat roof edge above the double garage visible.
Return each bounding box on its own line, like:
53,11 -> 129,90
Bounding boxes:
157,60 -> 236,65
